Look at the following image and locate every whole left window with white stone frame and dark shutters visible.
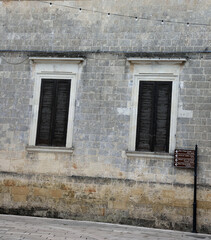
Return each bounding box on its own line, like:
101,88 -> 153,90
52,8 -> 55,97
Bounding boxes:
28,58 -> 83,151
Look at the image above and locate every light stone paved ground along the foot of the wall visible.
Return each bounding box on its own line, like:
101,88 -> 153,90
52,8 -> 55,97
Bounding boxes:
0,215 -> 211,240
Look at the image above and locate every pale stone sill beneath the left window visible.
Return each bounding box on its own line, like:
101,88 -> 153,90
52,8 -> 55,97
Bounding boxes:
26,146 -> 74,154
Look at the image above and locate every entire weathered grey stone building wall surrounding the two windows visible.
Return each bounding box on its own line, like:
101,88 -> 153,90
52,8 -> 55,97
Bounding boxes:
0,0 -> 211,233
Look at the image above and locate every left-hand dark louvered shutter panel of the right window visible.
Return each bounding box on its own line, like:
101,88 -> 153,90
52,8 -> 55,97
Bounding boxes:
136,82 -> 154,151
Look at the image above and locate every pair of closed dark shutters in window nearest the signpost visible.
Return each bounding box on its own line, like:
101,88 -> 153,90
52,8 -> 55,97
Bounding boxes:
136,81 -> 172,152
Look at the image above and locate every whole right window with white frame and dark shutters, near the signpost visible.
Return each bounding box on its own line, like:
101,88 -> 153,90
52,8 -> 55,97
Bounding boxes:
127,58 -> 186,156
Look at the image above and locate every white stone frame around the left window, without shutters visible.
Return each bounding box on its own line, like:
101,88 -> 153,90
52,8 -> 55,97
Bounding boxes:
26,57 -> 84,153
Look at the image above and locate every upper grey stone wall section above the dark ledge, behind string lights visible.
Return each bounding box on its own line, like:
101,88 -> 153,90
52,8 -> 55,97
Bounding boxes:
0,0 -> 211,52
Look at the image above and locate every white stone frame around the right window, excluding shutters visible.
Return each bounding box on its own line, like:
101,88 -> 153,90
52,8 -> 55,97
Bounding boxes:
126,58 -> 186,158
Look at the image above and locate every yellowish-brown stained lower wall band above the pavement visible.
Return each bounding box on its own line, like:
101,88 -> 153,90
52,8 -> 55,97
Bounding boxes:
0,173 -> 211,233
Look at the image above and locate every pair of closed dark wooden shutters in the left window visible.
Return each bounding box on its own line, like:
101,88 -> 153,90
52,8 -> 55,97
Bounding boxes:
36,79 -> 70,146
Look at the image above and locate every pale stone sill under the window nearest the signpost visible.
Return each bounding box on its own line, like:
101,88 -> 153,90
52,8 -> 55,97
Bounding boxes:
125,151 -> 174,160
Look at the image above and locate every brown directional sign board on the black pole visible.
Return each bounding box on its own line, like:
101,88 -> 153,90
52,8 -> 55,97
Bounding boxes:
174,149 -> 195,168
